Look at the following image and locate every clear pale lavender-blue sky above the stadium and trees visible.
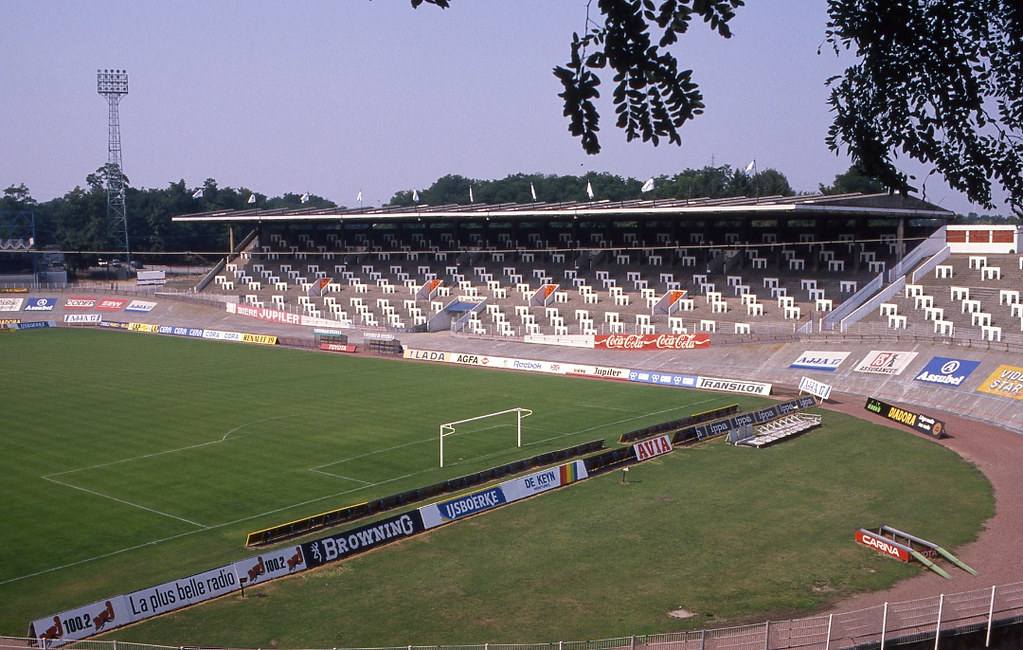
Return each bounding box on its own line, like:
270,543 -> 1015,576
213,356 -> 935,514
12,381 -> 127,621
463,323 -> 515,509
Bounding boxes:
0,0 -> 1010,214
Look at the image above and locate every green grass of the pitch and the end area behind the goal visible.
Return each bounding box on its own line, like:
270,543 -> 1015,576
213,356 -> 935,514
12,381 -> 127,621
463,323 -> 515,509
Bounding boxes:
0,329 -> 993,647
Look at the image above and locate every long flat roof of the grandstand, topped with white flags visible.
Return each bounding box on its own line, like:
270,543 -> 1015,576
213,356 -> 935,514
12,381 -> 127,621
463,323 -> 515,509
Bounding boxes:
173,192 -> 955,223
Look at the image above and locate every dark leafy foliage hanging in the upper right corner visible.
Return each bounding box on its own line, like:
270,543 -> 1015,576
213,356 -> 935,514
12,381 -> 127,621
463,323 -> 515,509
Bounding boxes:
828,0 -> 1023,211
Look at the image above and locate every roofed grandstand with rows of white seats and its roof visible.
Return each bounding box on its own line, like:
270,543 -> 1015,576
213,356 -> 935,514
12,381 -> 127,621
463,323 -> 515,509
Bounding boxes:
169,193 -> 998,340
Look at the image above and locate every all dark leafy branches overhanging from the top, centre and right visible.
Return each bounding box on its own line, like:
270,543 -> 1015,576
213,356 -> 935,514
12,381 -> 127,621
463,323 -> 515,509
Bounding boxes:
411,0 -> 1023,214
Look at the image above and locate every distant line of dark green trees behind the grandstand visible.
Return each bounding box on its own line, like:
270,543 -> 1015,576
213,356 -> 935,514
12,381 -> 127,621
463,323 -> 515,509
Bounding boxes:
0,165 -> 1018,270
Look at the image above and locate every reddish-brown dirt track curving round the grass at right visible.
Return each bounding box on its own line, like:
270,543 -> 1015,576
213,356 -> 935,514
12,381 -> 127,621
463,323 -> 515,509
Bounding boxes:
828,395 -> 1023,613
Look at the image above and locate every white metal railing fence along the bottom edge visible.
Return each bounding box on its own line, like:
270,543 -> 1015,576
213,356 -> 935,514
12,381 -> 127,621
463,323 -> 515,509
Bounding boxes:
6,582 -> 1023,650
